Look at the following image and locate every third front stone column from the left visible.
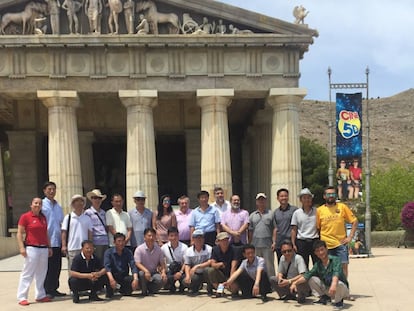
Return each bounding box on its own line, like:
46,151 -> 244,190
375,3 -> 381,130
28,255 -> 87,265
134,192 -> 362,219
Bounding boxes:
197,89 -> 234,201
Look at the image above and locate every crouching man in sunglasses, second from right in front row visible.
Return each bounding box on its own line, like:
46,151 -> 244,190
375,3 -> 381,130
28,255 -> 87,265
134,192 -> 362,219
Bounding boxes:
270,240 -> 310,303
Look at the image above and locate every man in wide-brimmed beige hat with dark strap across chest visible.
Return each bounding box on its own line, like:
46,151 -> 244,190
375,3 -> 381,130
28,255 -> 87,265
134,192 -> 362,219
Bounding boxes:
85,189 -> 109,262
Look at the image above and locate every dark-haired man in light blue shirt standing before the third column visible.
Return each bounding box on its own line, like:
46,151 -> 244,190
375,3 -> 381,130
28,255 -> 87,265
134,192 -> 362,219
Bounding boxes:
189,190 -> 220,246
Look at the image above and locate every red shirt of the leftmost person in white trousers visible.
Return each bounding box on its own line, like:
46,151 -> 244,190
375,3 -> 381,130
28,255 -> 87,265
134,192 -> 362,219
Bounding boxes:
18,211 -> 49,246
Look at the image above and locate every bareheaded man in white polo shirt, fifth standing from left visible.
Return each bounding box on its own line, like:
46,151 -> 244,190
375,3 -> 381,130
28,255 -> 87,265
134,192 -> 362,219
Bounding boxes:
106,193 -> 132,247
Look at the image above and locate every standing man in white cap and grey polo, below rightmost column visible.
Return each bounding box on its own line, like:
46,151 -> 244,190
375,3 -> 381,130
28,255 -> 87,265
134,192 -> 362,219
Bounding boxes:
249,192 -> 276,277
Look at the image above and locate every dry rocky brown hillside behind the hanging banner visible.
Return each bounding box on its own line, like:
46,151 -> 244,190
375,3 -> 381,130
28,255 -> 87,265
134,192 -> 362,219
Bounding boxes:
300,89 -> 414,169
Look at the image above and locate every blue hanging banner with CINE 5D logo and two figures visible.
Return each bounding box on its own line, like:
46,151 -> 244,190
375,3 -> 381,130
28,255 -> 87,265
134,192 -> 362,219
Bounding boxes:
336,93 -> 362,199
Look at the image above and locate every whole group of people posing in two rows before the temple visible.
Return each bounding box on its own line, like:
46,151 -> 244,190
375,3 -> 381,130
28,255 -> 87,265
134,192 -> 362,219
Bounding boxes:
17,182 -> 357,309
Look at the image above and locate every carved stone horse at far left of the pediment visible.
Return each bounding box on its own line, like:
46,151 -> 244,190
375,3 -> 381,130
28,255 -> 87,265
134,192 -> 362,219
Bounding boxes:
0,2 -> 46,35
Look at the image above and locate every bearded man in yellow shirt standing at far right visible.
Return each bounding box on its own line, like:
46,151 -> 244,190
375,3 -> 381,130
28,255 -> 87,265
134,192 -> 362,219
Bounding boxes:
316,187 -> 358,277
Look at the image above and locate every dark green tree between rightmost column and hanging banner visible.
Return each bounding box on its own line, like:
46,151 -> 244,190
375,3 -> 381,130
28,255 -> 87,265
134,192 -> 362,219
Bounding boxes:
300,137 -> 329,205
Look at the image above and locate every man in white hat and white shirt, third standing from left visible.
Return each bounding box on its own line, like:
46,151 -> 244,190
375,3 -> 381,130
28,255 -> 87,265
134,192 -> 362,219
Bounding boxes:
62,194 -> 92,271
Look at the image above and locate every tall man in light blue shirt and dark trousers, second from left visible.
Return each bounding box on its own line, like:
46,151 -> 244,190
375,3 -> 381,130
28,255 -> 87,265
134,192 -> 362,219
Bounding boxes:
42,181 -> 66,298
